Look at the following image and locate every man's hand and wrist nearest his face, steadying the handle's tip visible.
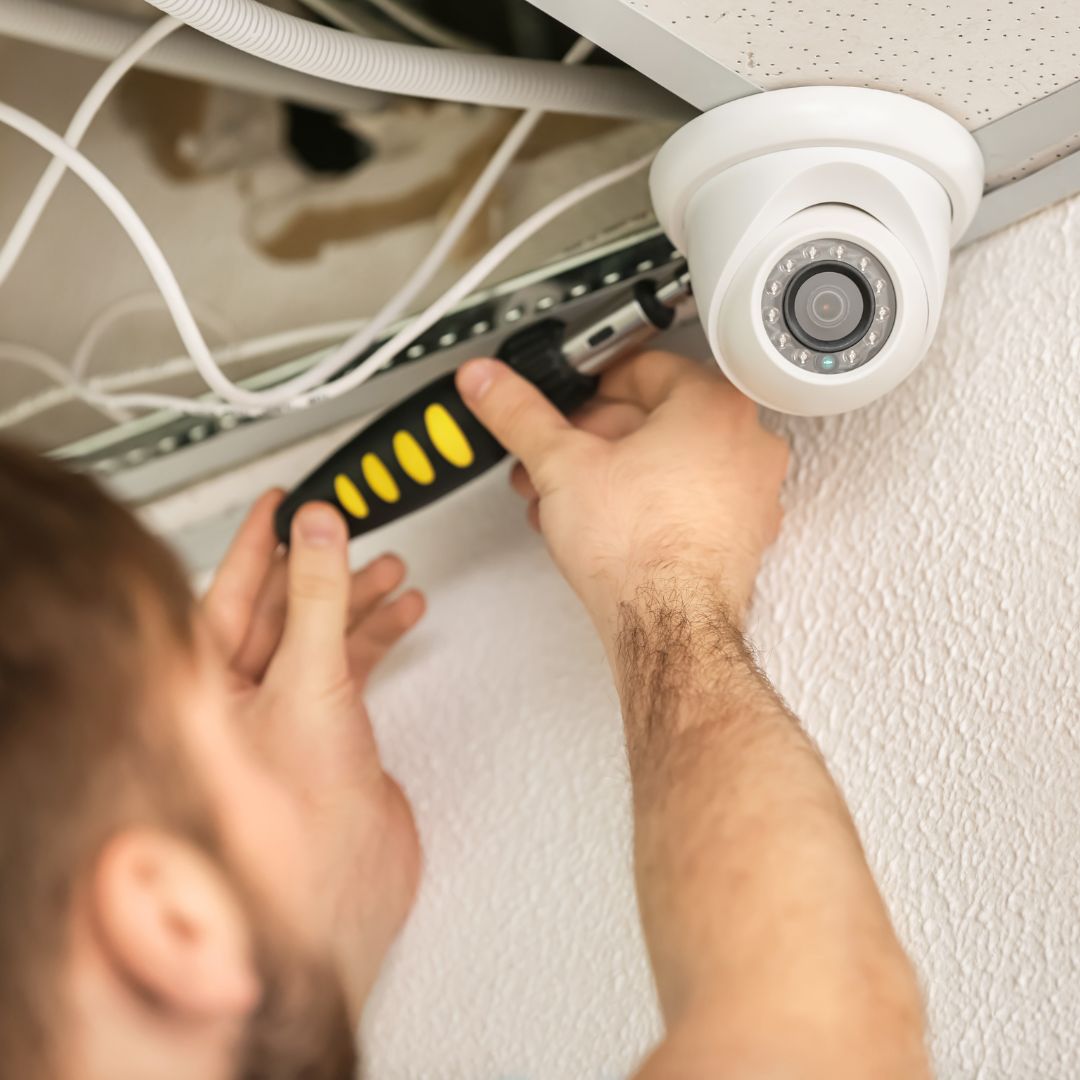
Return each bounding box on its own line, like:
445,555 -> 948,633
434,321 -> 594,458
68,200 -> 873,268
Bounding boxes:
204,491 -> 424,1014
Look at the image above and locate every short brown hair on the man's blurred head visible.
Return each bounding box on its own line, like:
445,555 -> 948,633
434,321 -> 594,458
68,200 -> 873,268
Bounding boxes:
0,443 -> 193,1077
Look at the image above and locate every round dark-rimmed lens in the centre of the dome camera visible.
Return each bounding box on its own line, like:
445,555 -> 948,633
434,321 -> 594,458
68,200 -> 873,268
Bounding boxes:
784,262 -> 874,352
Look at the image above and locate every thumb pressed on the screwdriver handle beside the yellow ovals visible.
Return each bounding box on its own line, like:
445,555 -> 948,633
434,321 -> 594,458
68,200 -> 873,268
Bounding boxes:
457,360 -> 573,480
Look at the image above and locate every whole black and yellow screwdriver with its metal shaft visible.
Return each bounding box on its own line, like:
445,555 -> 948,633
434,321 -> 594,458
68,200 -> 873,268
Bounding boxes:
275,269 -> 690,543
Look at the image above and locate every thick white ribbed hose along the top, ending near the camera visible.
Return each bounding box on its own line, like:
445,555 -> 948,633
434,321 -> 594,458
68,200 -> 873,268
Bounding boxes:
139,0 -> 689,119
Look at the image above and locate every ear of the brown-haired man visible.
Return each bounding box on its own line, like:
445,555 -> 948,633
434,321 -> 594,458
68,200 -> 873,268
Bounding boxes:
91,827 -> 261,1020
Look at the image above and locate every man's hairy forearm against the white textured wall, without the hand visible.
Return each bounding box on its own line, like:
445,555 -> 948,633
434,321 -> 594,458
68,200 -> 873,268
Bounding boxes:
611,578 -> 926,1080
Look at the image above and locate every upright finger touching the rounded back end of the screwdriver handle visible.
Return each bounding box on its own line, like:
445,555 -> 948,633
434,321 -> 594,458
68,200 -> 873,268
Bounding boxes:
275,502 -> 350,686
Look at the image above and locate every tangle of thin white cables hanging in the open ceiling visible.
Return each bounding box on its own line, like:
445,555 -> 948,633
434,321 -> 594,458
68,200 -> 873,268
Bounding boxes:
0,8 -> 651,426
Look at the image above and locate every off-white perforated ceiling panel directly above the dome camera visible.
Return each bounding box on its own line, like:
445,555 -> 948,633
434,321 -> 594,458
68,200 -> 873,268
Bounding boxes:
624,0 -> 1080,127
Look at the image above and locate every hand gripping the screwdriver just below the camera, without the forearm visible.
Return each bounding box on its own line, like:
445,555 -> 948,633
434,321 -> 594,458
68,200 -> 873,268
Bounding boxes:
458,352 -> 787,642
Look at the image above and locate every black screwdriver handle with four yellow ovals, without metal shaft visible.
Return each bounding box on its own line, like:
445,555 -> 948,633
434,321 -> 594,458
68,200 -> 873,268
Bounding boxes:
275,320 -> 596,543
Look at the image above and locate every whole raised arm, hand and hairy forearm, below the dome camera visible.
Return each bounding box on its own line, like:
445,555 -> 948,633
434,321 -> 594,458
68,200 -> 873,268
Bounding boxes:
458,353 -> 928,1080
